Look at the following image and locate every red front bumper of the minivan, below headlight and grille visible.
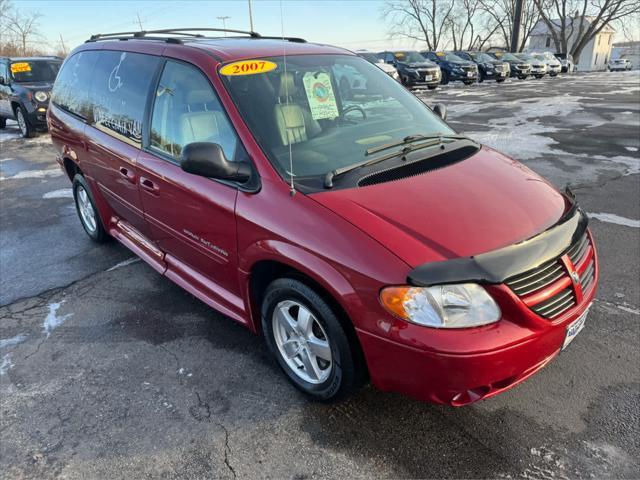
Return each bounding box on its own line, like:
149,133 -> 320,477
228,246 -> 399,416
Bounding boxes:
358,276 -> 597,406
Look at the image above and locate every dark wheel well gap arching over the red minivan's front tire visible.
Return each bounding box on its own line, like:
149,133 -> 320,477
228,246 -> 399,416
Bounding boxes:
249,260 -> 369,383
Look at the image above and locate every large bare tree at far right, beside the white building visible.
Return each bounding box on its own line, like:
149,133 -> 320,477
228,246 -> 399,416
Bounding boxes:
533,0 -> 640,63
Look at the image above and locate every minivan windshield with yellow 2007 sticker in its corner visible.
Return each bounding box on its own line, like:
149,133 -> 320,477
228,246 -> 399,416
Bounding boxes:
220,55 -> 454,184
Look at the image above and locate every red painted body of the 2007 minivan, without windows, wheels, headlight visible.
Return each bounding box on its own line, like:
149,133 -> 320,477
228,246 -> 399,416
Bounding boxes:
48,39 -> 599,405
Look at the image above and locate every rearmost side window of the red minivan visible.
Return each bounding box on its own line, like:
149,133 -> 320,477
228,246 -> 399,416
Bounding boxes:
51,51 -> 99,120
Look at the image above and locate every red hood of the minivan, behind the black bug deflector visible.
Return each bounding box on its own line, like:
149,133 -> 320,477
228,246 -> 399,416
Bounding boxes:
310,147 -> 568,267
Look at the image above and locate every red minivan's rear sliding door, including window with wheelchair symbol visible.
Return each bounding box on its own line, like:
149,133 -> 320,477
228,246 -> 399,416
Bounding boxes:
85,51 -> 161,234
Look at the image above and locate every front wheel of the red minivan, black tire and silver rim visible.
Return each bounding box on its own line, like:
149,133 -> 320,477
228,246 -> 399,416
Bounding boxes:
261,278 -> 357,402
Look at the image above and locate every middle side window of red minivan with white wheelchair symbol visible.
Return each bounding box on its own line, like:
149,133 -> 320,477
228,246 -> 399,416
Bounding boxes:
91,50 -> 160,146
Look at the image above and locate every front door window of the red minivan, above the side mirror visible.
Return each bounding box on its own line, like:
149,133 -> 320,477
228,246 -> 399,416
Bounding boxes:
150,61 -> 237,160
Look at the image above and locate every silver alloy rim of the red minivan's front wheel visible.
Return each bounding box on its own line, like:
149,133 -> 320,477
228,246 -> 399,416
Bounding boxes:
272,300 -> 333,384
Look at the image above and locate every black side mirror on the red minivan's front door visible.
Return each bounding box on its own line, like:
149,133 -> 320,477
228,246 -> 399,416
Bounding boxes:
180,142 -> 251,183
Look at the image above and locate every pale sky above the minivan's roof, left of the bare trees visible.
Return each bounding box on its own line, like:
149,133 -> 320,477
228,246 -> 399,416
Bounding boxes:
13,0 -> 422,50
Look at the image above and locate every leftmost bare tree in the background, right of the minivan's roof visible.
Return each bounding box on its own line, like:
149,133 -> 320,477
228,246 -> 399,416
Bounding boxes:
383,0 -> 455,50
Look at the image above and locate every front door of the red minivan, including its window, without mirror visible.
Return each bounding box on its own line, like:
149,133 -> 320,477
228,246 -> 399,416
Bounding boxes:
138,60 -> 244,318
